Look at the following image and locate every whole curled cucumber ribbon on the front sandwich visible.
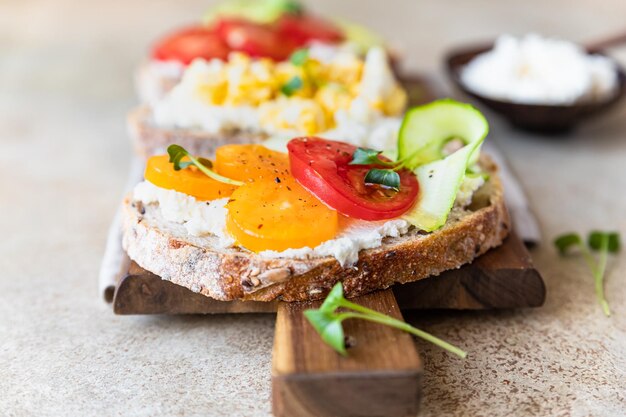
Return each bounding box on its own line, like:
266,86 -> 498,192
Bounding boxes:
398,99 -> 489,232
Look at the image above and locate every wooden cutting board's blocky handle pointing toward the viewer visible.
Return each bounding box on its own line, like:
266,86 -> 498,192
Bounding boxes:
272,290 -> 422,417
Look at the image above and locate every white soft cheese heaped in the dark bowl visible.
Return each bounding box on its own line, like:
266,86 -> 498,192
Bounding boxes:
460,34 -> 618,105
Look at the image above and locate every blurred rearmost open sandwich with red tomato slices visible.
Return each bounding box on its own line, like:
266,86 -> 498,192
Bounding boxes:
135,0 -> 382,102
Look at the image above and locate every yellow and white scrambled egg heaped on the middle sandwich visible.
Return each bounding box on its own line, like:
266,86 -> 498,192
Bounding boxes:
187,48 -> 407,134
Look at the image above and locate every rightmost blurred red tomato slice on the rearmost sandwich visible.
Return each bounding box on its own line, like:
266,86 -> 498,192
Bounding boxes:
276,14 -> 344,46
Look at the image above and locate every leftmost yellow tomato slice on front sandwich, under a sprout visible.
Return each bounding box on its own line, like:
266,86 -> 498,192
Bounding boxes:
144,155 -> 237,200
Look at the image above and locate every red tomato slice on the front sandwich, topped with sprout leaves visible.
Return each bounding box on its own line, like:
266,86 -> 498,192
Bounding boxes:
287,137 -> 419,220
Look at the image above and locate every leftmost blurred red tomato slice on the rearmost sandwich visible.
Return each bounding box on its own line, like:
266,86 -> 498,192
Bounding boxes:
152,26 -> 230,65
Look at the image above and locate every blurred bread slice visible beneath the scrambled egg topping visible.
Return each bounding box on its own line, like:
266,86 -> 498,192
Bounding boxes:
128,105 -> 267,158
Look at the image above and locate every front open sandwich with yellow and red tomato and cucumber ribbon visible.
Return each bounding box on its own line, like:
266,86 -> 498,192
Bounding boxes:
123,100 -> 509,301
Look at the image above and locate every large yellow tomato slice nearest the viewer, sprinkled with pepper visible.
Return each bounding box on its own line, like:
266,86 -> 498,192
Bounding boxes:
226,176 -> 337,252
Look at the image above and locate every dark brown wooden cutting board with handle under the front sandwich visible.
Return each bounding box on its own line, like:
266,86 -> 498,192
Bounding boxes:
113,234 -> 545,417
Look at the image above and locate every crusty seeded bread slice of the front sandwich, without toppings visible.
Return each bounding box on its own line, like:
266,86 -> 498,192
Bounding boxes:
123,157 -> 510,301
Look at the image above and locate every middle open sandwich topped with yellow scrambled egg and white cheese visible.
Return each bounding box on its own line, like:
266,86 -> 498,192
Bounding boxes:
129,40 -> 407,157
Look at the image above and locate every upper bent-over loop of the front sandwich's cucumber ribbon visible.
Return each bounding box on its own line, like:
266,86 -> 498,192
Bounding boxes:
398,99 -> 489,168
